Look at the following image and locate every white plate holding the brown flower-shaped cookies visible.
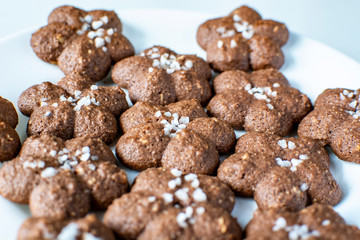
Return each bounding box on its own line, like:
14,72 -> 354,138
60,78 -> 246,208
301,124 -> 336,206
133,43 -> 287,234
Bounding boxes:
0,9 -> 360,240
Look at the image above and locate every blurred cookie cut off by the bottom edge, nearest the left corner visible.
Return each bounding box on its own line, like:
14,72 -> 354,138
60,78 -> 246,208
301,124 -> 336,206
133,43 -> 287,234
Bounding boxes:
17,214 -> 115,240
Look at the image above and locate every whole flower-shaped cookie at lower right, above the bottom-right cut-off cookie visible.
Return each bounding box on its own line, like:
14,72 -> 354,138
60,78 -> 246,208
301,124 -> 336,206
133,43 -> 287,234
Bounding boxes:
218,132 -> 341,211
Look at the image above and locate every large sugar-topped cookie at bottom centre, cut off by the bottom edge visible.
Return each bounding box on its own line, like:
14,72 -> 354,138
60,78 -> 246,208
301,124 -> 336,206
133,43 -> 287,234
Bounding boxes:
104,168 -> 241,240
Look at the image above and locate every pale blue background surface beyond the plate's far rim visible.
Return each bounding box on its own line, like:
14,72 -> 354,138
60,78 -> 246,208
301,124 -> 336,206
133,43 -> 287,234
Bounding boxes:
0,0 -> 360,62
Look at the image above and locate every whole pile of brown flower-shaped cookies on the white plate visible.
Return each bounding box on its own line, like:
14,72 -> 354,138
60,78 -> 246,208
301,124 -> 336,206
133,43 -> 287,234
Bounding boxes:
0,3 -> 360,240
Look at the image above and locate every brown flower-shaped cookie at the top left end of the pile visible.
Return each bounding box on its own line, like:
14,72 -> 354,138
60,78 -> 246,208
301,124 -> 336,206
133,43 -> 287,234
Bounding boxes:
31,6 -> 134,81
